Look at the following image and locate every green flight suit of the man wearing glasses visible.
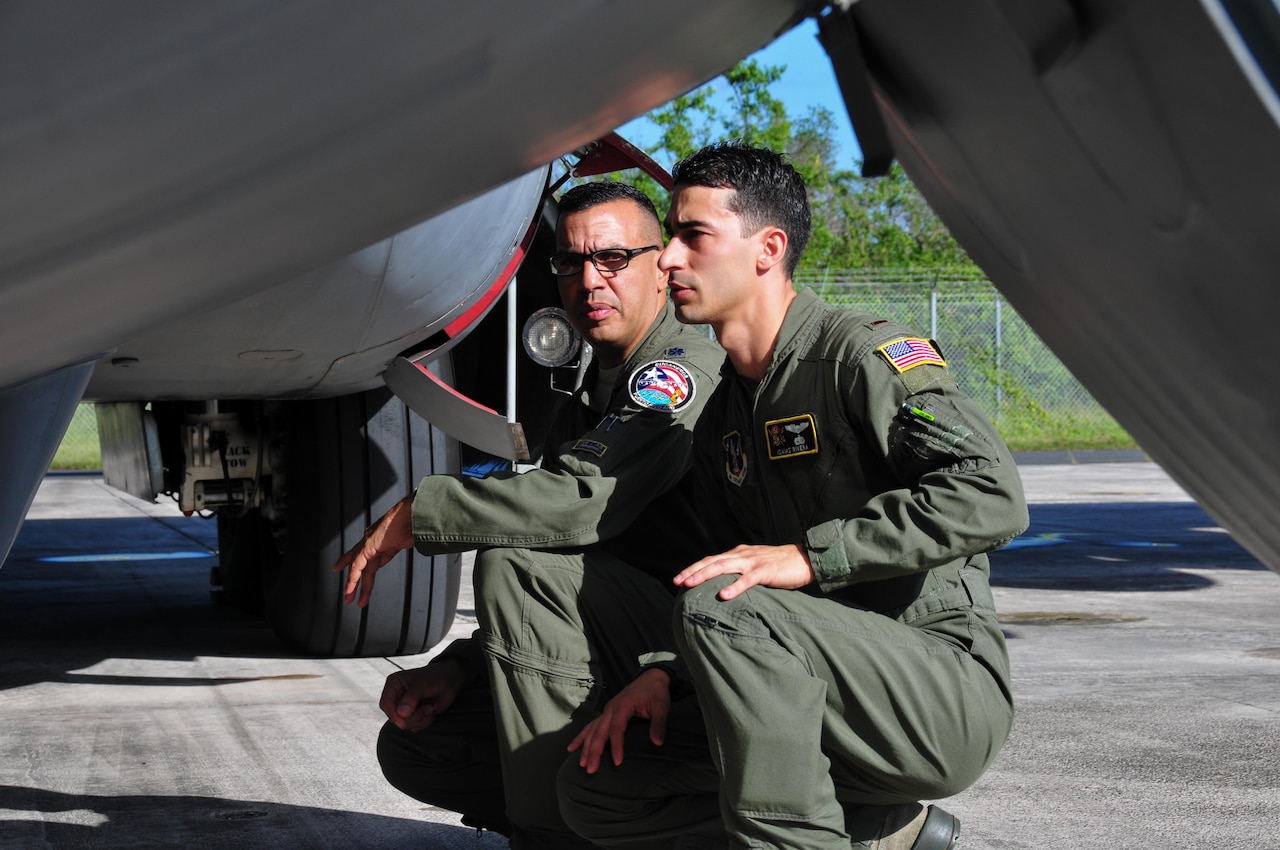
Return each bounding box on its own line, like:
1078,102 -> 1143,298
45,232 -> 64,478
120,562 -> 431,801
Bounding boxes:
379,305 -> 724,844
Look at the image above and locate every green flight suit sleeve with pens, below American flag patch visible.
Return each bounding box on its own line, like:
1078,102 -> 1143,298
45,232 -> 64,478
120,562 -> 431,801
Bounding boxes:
806,341 -> 1029,591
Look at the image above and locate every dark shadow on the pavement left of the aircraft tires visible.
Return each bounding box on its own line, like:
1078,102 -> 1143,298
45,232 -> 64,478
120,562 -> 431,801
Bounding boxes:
0,518 -> 298,690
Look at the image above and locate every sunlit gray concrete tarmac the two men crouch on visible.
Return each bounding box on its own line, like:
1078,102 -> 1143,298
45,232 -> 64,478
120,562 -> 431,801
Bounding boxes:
0,462 -> 1280,850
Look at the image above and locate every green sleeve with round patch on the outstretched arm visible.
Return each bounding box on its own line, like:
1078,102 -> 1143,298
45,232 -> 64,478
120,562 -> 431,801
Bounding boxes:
413,361 -> 716,554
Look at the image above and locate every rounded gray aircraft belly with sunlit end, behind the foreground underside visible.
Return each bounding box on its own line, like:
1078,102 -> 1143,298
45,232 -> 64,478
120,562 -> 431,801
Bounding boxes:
86,168 -> 548,401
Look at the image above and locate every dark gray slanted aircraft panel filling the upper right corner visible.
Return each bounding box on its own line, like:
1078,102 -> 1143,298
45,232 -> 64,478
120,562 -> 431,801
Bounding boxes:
824,0 -> 1280,571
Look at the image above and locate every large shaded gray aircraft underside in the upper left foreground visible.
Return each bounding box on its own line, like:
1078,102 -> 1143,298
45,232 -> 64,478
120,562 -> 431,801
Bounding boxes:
0,0 -> 809,387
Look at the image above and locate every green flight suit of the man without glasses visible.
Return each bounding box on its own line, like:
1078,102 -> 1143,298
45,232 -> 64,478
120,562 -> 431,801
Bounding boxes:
559,291 -> 1028,849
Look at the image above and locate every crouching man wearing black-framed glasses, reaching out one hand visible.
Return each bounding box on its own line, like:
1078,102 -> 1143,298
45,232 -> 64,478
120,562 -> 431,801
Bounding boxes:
334,183 -> 724,847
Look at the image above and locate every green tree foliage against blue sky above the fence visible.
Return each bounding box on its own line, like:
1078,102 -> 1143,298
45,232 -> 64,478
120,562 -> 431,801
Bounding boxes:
614,59 -> 973,271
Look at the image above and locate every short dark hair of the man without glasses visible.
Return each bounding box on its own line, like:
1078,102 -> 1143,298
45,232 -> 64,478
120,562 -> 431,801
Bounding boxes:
671,140 -> 810,275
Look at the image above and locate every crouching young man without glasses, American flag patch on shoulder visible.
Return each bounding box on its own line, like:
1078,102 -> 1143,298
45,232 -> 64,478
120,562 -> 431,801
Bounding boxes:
561,143 -> 1028,850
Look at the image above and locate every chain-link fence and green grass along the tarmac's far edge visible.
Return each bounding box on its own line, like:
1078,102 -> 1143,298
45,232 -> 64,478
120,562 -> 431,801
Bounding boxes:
54,269 -> 1133,469
